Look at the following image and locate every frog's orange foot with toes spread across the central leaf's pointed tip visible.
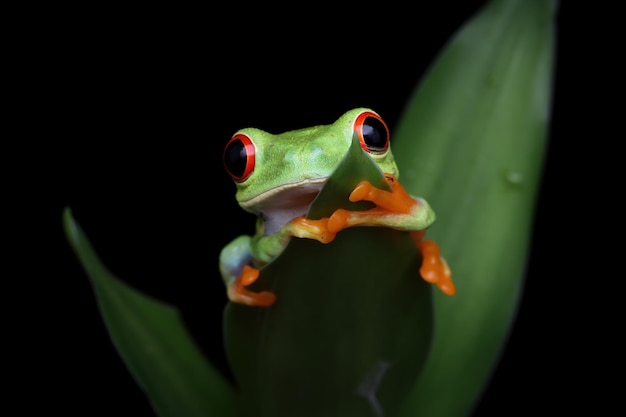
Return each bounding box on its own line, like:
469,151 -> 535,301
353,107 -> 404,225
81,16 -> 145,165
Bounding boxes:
328,174 -> 420,233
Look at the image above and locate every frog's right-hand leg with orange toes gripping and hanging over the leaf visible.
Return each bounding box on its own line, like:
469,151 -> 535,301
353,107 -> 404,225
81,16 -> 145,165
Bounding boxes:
328,174 -> 456,295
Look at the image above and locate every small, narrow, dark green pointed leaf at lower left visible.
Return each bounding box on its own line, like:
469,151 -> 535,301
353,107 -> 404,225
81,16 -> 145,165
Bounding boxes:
63,208 -> 235,417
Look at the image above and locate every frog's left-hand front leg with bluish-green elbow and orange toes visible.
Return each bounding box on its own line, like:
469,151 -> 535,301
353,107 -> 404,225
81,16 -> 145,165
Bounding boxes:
220,217 -> 336,307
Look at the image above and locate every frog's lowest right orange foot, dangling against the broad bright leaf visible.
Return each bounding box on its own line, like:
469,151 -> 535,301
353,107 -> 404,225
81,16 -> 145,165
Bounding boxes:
411,230 -> 456,295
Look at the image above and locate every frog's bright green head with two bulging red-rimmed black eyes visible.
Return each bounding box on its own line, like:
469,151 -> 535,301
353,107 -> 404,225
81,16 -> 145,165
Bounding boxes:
224,108 -> 398,234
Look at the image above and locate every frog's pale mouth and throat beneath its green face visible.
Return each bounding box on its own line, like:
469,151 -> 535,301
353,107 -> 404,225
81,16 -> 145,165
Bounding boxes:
240,177 -> 328,235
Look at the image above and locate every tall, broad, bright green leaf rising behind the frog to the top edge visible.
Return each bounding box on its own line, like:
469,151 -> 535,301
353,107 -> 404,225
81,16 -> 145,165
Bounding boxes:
392,0 -> 556,417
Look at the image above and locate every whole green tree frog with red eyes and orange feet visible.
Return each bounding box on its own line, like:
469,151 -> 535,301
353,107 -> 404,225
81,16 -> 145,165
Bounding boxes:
219,107 -> 456,307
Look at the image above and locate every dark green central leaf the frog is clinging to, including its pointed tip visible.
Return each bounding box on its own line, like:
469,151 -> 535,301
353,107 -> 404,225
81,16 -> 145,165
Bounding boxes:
224,137 -> 432,417
